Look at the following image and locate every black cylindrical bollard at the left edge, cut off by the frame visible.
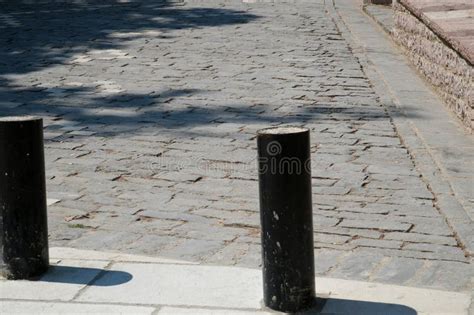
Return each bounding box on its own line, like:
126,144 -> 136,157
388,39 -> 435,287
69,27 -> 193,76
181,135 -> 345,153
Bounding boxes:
0,117 -> 49,279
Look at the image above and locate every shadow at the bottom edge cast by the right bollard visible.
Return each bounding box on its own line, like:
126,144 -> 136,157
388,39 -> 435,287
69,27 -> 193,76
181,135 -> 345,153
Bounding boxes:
295,298 -> 418,315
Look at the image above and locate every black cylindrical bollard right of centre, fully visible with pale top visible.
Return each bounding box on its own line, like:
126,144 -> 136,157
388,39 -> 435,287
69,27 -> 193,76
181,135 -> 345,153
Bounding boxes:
257,127 -> 315,312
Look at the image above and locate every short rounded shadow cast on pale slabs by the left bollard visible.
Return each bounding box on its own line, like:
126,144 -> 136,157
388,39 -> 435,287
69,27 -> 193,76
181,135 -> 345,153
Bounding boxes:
37,266 -> 133,287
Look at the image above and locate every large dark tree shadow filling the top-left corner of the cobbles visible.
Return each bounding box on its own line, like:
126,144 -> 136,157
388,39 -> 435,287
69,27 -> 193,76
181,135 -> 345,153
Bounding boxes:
0,0 -> 258,77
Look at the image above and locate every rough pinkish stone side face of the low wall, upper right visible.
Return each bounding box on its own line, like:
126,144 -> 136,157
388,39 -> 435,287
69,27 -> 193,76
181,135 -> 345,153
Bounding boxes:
393,2 -> 474,132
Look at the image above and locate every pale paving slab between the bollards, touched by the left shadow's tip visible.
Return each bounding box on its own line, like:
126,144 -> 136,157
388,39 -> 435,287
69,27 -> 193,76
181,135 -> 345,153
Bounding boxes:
78,263 -> 262,309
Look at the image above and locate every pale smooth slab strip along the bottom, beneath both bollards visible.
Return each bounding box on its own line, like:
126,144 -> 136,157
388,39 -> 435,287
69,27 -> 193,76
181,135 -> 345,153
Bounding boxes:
0,248 -> 470,315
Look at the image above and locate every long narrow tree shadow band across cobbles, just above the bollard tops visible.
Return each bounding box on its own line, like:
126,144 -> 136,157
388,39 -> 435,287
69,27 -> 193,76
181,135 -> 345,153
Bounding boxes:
0,87 -> 422,141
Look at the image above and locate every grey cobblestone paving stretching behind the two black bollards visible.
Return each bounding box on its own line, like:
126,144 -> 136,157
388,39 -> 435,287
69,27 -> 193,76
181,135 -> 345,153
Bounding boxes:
0,0 -> 474,291
